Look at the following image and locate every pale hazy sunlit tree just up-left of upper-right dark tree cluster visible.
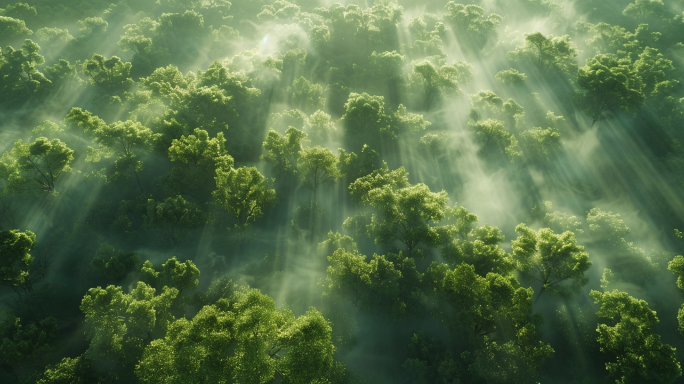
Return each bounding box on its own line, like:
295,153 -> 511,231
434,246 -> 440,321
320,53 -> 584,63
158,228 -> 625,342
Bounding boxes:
506,32 -> 577,75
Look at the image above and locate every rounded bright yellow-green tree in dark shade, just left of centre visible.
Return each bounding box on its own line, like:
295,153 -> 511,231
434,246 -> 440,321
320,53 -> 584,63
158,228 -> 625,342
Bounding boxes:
212,167 -> 278,228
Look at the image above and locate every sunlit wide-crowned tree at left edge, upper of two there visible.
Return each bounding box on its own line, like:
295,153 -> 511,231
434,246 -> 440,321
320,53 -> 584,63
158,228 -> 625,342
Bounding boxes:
0,137 -> 74,192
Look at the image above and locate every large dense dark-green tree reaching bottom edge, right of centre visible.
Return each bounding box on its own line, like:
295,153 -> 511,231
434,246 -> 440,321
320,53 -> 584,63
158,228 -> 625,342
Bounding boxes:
424,263 -> 554,383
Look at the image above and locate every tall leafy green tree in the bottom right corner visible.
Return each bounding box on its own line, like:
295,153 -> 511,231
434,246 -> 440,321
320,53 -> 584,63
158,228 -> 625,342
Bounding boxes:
590,290 -> 682,384
